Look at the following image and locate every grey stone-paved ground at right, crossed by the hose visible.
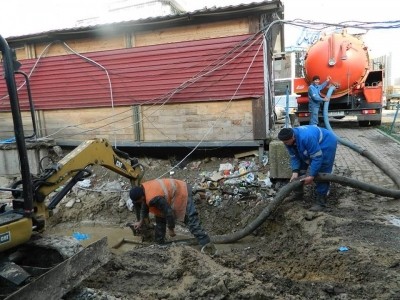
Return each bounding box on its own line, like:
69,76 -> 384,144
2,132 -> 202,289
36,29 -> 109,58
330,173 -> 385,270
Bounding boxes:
333,126 -> 400,189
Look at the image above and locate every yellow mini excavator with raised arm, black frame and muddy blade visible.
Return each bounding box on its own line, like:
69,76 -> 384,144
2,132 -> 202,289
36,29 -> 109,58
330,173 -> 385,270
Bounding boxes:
0,36 -> 144,300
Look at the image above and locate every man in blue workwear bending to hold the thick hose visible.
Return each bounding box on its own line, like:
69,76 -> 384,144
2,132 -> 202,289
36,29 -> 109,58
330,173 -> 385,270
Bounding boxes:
278,125 -> 337,211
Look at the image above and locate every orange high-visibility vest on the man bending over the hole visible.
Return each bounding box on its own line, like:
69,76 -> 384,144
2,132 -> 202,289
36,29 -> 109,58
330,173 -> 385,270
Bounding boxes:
142,178 -> 188,222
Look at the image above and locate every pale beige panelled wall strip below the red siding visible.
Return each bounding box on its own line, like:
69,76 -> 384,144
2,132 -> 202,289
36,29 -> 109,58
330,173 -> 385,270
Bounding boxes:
0,100 -> 261,145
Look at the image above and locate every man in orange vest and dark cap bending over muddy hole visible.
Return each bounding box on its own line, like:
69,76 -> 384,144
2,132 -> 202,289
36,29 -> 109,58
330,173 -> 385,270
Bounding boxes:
129,178 -> 216,255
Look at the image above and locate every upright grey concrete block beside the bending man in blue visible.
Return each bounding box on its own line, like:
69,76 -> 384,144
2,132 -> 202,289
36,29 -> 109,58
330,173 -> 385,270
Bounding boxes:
269,140 -> 292,179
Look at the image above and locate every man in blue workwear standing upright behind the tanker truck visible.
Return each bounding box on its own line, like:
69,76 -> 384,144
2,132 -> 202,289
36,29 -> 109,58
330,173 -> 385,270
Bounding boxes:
308,75 -> 331,125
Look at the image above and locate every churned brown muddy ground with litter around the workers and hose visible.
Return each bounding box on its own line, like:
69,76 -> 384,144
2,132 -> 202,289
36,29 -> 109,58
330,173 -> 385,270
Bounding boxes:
34,126 -> 400,300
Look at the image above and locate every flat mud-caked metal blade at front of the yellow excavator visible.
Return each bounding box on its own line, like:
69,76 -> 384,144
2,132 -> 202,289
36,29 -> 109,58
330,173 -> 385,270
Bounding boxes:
4,237 -> 110,300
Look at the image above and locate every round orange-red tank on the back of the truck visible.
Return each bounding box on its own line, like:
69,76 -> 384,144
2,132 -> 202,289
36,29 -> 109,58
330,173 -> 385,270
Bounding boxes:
304,32 -> 369,98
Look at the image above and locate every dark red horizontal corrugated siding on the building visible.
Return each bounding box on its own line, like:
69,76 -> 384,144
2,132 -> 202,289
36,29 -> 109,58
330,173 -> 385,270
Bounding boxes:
0,35 -> 263,111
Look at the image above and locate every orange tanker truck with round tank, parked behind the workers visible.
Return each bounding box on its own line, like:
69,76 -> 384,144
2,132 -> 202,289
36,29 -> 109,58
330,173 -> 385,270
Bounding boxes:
293,32 -> 383,126
